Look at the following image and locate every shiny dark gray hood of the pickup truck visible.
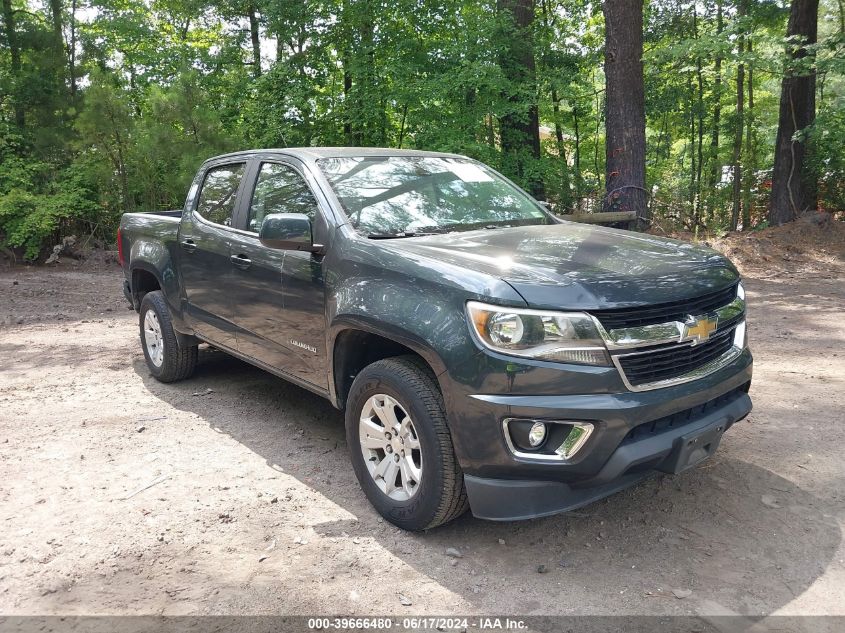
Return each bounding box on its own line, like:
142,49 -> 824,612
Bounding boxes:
382,222 -> 739,310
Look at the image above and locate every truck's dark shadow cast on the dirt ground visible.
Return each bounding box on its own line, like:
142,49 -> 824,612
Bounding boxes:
134,348 -> 841,615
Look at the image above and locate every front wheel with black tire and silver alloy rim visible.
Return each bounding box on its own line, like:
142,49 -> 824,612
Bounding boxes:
346,356 -> 469,530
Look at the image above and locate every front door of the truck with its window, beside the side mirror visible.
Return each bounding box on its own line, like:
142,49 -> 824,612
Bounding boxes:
227,159 -> 328,389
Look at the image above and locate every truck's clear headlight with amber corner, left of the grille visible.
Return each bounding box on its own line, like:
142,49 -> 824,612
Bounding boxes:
467,301 -> 610,366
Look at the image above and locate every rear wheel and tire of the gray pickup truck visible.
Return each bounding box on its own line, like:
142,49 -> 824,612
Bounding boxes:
138,290 -> 197,382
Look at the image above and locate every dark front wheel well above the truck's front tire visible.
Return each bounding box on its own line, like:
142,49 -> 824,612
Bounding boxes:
332,330 -> 436,407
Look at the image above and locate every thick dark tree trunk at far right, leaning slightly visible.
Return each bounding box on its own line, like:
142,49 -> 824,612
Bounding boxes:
769,0 -> 819,226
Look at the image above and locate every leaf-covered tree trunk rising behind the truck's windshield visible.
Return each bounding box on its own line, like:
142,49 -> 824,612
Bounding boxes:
496,0 -> 544,199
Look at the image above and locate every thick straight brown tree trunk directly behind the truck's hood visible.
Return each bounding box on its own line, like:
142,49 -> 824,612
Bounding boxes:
603,0 -> 649,226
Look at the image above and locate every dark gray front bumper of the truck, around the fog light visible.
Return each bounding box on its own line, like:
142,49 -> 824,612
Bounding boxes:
446,349 -> 752,521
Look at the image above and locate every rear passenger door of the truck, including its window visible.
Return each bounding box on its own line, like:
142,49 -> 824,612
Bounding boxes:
178,161 -> 247,349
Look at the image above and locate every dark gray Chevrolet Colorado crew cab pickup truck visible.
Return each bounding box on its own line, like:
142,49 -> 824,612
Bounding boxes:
118,148 -> 752,530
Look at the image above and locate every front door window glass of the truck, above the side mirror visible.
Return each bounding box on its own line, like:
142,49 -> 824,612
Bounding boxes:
247,163 -> 317,233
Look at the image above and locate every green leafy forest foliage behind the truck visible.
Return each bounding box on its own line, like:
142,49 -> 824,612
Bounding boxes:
0,0 -> 845,259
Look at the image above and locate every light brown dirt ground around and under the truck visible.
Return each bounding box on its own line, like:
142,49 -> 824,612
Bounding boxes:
0,226 -> 845,616
